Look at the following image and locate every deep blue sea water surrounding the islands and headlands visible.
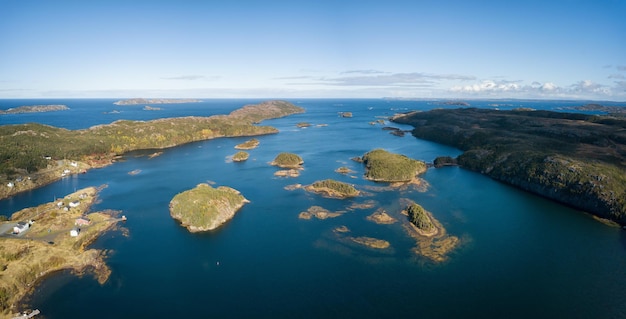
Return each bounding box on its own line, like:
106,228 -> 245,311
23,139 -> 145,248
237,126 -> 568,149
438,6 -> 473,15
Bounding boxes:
0,99 -> 626,318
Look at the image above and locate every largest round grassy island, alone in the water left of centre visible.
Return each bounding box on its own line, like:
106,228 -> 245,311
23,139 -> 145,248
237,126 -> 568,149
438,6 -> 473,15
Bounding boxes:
170,183 -> 249,232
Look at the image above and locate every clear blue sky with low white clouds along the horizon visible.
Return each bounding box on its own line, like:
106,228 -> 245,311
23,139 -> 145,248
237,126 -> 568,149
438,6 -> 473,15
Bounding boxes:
0,0 -> 626,101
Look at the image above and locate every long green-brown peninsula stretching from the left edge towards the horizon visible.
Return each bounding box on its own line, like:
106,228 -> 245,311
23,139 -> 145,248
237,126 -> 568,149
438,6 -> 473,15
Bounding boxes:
0,101 -> 304,199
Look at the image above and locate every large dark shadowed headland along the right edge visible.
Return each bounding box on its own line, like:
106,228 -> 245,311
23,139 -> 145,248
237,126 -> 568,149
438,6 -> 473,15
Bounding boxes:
392,108 -> 626,225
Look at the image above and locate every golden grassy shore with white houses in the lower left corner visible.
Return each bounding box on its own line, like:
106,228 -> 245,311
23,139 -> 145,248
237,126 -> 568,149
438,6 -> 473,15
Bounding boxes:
0,187 -> 121,317
